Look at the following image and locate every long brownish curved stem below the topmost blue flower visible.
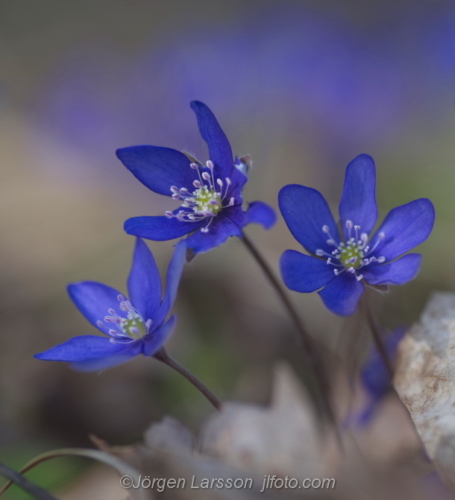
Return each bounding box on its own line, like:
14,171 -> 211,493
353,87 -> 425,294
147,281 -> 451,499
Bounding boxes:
242,233 -> 338,429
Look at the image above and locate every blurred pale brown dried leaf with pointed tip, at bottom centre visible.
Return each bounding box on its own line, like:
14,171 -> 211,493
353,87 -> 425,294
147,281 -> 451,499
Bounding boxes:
201,364 -> 329,478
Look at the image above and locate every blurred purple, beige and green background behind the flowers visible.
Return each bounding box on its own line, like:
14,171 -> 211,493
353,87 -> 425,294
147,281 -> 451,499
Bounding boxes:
0,0 -> 455,498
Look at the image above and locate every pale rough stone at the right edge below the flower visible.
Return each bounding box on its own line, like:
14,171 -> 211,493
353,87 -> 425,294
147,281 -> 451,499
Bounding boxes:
394,292 -> 455,487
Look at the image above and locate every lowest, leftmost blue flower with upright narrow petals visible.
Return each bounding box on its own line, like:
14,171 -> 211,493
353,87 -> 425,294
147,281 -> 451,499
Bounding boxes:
35,238 -> 185,371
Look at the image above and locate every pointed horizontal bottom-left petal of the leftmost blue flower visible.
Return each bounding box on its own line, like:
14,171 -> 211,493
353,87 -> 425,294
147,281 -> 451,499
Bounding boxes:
35,335 -> 142,371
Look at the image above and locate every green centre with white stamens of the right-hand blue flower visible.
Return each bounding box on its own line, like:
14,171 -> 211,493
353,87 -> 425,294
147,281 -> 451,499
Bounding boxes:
316,220 -> 385,281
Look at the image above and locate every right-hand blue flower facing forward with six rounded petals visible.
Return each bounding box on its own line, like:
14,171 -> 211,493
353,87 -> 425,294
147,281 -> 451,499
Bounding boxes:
279,155 -> 435,316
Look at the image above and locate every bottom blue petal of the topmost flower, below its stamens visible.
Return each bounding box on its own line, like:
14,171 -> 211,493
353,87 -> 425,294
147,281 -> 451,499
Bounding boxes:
185,209 -> 243,254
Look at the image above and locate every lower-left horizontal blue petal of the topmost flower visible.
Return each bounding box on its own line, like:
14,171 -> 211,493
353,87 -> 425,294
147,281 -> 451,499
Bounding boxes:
123,215 -> 201,241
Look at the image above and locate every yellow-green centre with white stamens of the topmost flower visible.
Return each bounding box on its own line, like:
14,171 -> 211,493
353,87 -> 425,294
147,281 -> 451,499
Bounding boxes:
165,160 -> 235,233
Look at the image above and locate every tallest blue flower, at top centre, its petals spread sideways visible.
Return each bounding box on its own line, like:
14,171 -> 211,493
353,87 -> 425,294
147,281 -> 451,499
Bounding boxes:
117,101 -> 275,254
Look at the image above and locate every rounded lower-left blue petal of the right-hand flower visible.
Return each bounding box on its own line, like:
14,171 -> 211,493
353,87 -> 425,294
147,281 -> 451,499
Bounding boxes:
280,250 -> 335,293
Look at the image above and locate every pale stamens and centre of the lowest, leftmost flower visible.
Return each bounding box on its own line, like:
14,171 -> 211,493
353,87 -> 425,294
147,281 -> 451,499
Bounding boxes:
98,295 -> 152,342
